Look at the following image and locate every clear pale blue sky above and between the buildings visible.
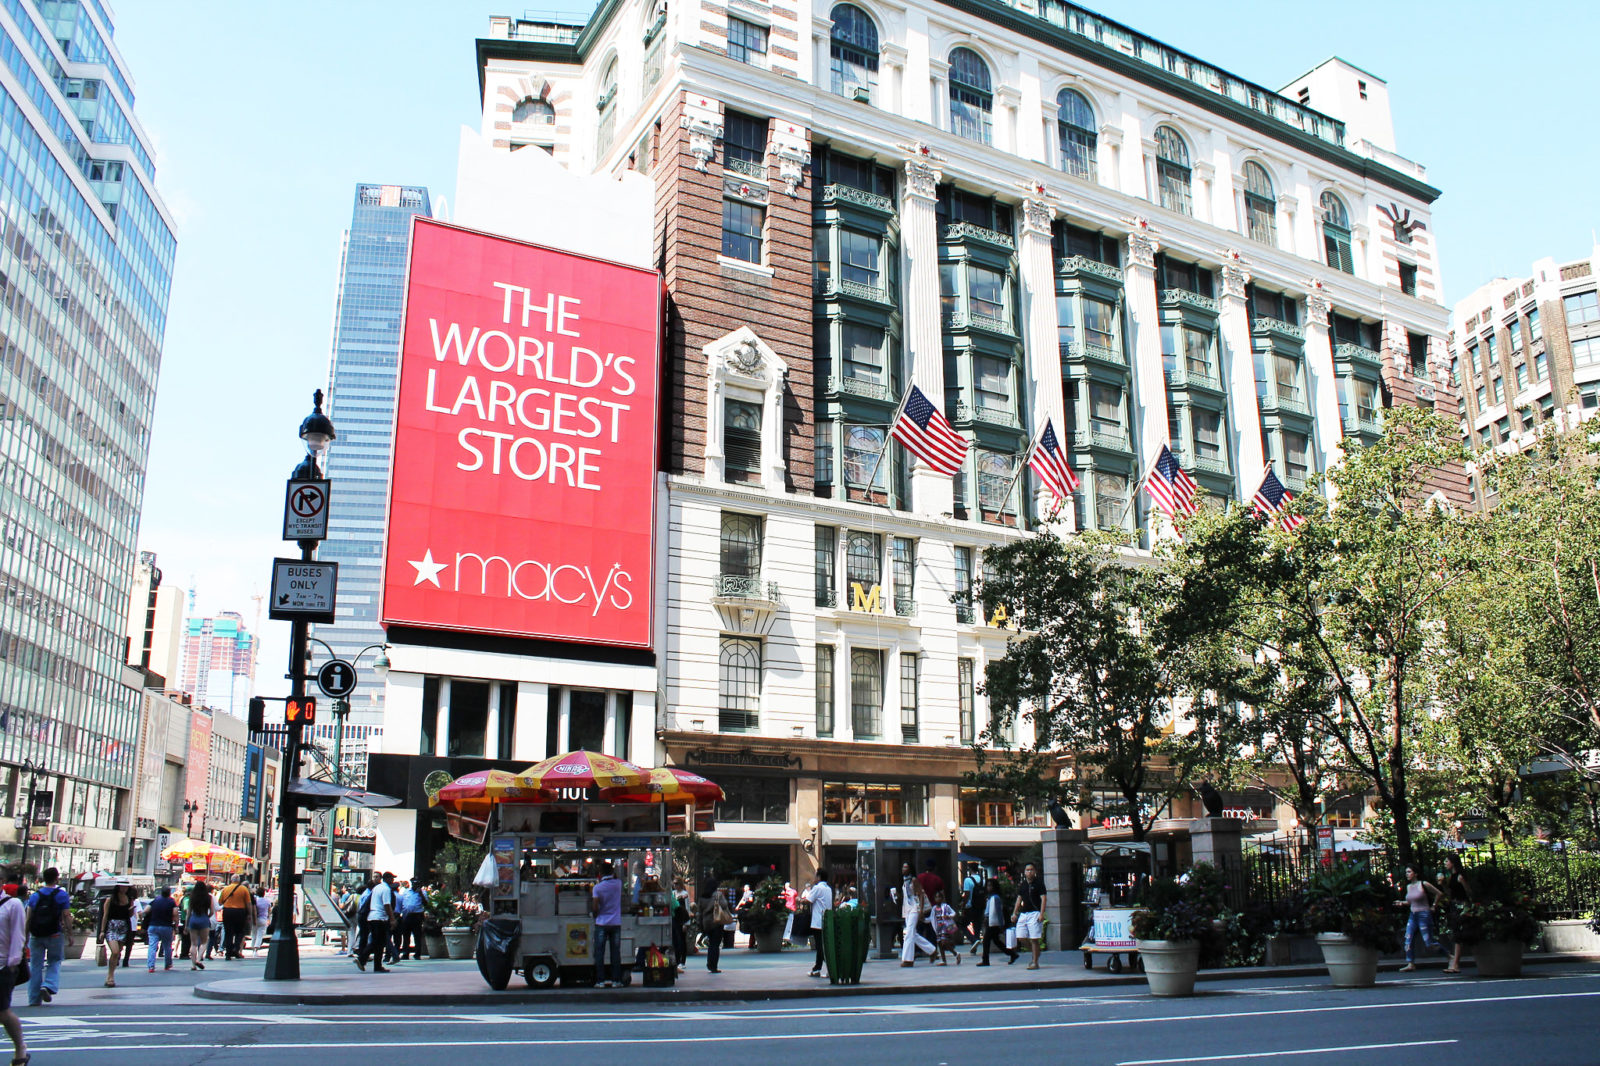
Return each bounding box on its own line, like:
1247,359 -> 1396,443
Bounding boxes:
117,0 -> 1600,695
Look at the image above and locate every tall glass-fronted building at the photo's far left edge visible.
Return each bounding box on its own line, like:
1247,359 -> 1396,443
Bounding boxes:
0,0 -> 176,869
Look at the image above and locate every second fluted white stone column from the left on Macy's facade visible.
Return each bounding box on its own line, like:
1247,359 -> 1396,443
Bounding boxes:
1016,195 -> 1072,528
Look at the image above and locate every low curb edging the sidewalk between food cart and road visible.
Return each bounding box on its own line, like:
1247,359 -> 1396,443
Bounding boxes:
194,954 -> 1600,1007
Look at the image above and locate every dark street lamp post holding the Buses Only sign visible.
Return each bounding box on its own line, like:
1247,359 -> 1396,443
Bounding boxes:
264,389 -> 336,981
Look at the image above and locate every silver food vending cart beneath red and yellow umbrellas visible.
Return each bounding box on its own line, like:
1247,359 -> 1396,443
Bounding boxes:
476,802 -> 672,988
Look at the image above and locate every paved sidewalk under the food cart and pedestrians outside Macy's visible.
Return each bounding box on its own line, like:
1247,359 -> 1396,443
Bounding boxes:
195,949 -> 1582,1007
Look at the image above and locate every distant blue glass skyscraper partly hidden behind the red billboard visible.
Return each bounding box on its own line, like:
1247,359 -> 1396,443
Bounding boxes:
312,184 -> 432,729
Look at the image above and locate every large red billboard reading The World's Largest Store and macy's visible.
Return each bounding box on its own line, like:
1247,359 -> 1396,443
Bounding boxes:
382,218 -> 661,647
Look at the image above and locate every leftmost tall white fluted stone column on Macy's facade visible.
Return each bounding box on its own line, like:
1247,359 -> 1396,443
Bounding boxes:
901,146 -> 955,517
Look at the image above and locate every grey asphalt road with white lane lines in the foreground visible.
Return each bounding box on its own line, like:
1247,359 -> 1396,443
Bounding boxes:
21,962 -> 1600,1066
